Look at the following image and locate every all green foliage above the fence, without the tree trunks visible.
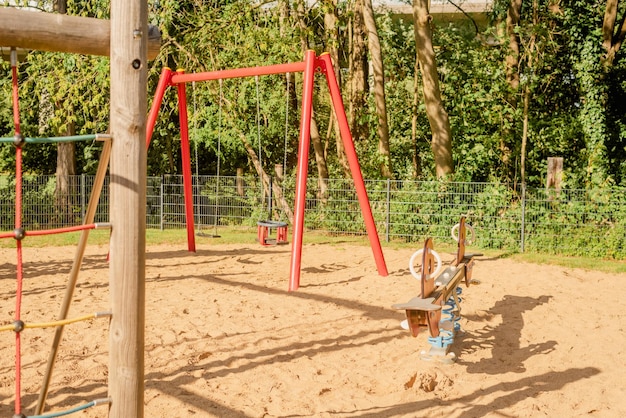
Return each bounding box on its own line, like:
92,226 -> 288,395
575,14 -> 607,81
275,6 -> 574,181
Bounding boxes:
0,0 -> 626,187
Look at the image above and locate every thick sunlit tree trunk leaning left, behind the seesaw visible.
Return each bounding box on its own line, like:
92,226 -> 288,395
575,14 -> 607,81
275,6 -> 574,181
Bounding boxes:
413,0 -> 454,178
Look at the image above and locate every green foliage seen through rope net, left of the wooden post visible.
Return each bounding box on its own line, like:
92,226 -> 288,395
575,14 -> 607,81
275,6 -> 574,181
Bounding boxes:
0,0 -> 109,174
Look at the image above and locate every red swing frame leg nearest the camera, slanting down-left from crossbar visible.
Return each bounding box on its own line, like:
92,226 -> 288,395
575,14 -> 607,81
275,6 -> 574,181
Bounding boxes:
289,51 -> 316,291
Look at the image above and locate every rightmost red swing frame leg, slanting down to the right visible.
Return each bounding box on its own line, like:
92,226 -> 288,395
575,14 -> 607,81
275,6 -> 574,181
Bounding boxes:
318,54 -> 389,276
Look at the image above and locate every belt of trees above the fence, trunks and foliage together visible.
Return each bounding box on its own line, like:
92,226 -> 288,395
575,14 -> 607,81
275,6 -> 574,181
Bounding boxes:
6,0 -> 626,189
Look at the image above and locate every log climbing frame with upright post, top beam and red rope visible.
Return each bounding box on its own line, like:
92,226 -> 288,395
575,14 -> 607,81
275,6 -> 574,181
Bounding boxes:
0,0 -> 150,418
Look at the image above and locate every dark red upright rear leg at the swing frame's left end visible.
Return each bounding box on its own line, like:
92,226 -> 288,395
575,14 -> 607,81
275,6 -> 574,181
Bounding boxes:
176,70 -> 196,253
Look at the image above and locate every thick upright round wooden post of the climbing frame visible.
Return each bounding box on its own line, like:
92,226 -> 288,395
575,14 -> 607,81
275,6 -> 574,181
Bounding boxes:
109,0 -> 148,418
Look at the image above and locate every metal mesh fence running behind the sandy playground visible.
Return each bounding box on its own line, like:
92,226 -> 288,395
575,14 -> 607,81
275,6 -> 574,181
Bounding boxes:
0,175 -> 626,259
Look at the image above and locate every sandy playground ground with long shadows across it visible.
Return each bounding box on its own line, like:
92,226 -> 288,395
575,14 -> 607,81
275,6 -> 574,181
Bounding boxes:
0,240 -> 626,418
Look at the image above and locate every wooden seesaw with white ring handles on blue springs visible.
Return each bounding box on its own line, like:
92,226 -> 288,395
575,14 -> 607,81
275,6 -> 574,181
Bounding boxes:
392,216 -> 481,363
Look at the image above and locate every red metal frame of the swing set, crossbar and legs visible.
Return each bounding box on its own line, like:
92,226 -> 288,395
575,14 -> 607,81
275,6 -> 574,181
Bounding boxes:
146,51 -> 388,291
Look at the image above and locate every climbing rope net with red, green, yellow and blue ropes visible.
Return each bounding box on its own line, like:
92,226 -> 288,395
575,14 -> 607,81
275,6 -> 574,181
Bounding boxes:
0,49 -> 111,418
